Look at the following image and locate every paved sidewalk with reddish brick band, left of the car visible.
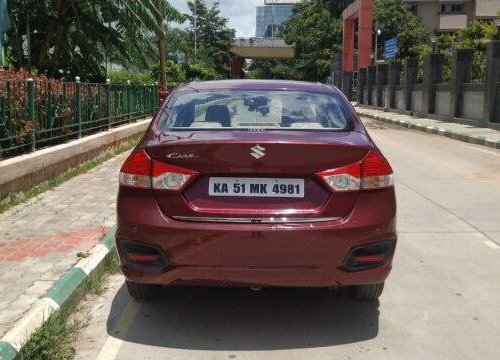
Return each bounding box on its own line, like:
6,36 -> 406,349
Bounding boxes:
0,153 -> 128,338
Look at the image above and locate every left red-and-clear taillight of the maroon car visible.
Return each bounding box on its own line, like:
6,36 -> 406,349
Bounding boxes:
119,150 -> 197,191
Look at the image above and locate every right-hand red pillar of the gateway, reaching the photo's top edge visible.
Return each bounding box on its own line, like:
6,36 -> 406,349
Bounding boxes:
358,0 -> 373,68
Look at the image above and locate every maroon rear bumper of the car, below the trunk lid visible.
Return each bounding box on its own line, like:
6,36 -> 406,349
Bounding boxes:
116,189 -> 396,287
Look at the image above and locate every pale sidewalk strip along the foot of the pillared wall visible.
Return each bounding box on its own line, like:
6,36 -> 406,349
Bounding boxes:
354,106 -> 500,149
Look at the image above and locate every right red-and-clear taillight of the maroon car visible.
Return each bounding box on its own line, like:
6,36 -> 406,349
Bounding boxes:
317,151 -> 394,192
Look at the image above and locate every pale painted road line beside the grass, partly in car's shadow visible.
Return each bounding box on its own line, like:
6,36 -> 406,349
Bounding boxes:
96,300 -> 140,360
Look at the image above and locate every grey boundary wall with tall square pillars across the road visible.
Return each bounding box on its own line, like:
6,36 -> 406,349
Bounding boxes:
352,41 -> 500,130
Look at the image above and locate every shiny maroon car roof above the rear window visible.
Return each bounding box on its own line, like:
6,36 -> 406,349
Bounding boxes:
176,80 -> 338,93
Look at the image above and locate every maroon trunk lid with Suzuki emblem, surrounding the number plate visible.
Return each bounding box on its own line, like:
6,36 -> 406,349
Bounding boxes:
147,131 -> 369,222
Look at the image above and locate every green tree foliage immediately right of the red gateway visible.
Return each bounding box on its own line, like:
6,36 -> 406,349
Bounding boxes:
373,0 -> 430,58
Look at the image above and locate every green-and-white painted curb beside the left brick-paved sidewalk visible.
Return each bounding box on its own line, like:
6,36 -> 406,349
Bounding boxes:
0,228 -> 116,360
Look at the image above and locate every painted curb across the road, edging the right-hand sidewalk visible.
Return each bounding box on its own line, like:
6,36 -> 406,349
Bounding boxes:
355,107 -> 500,149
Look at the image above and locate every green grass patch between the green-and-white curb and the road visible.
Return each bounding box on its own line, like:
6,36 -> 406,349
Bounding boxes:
18,249 -> 120,360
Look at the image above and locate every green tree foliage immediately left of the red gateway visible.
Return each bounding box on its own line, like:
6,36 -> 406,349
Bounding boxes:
284,0 -> 350,80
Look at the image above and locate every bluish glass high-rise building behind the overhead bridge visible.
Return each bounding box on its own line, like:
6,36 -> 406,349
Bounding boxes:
255,0 -> 301,38
